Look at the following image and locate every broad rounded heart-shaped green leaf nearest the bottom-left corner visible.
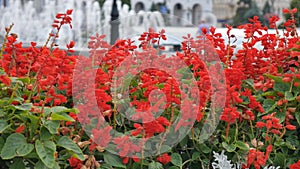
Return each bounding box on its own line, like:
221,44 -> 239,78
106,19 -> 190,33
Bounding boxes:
1,133 -> 33,160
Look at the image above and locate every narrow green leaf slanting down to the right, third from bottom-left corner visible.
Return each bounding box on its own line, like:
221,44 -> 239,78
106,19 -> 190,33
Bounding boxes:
57,136 -> 84,161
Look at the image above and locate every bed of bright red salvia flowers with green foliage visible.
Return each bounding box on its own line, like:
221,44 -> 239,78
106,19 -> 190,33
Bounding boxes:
0,9 -> 300,169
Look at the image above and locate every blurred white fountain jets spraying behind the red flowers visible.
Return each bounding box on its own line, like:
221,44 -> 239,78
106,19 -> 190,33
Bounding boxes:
0,0 -> 164,48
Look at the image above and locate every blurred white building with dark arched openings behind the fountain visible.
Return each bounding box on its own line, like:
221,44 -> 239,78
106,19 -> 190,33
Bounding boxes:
131,0 -> 216,26
